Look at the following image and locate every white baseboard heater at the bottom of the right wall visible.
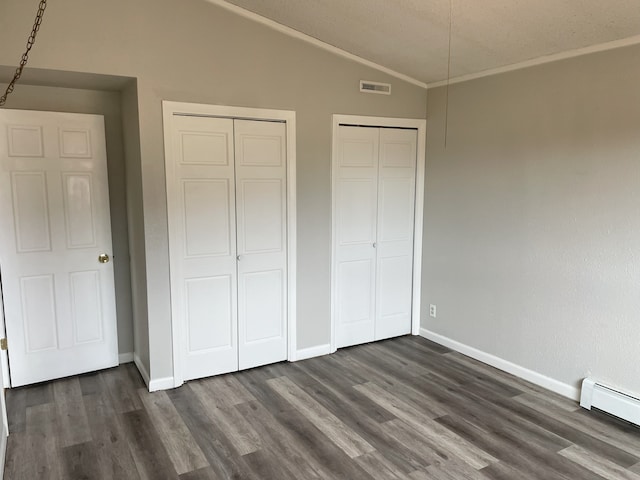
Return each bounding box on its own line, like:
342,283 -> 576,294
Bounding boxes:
580,378 -> 640,426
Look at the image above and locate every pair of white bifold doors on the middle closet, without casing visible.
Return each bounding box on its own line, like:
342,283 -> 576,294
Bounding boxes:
166,115 -> 287,380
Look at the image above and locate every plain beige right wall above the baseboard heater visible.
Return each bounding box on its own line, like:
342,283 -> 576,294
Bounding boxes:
422,46 -> 640,394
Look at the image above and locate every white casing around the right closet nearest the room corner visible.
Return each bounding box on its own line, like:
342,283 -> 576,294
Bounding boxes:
331,114 -> 427,353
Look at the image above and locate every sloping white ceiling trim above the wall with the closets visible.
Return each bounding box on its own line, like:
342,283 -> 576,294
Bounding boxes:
207,0 -> 427,88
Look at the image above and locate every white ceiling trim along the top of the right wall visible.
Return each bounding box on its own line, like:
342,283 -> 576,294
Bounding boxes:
427,35 -> 640,89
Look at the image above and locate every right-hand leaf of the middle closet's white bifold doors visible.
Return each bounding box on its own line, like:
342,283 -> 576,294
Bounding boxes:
234,120 -> 287,369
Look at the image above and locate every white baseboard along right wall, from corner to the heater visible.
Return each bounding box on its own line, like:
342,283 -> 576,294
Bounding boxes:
420,328 -> 580,401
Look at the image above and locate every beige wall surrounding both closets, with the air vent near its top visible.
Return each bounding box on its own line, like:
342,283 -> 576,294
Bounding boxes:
0,0 -> 426,379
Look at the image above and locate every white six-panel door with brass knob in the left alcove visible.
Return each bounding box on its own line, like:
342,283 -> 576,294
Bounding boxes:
0,110 -> 118,387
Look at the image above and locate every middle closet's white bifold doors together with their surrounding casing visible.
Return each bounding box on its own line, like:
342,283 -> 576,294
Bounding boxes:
163,102 -> 295,386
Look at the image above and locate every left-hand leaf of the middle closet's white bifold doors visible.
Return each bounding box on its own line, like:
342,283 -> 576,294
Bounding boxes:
167,116 -> 238,380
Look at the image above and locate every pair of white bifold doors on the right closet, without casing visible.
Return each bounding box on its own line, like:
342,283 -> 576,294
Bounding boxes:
333,125 -> 417,348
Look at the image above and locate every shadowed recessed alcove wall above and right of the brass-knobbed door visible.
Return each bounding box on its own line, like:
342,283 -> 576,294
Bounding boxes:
0,85 -> 133,353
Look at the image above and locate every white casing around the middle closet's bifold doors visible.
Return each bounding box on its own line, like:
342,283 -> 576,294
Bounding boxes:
162,100 -> 297,387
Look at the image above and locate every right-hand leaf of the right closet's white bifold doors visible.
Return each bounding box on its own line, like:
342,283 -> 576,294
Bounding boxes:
375,128 -> 418,340
